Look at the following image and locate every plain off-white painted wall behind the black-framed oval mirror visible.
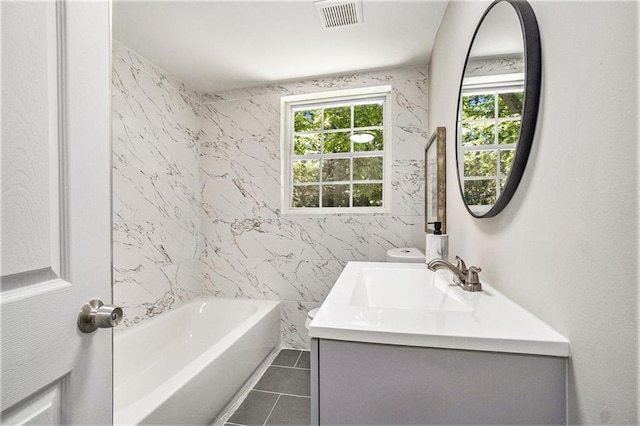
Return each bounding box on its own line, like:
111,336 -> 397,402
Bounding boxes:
428,1 -> 638,424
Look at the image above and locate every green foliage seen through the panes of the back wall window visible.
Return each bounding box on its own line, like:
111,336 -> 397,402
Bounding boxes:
291,101 -> 384,208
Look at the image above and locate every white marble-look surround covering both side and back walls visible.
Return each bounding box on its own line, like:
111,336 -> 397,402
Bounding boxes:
113,41 -> 428,348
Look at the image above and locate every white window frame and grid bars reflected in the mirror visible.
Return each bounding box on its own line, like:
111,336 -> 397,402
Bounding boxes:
458,73 -> 524,214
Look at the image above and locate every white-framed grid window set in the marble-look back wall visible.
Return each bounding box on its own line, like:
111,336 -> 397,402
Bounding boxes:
281,86 -> 391,213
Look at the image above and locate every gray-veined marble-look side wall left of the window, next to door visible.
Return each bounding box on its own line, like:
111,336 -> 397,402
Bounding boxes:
112,40 -> 202,329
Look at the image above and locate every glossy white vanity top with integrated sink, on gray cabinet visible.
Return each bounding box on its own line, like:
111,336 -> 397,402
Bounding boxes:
309,262 -> 570,357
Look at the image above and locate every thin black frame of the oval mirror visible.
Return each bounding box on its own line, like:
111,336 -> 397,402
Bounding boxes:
455,0 -> 542,218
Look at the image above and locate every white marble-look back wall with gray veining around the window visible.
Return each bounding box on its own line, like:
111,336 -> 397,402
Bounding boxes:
200,68 -> 428,348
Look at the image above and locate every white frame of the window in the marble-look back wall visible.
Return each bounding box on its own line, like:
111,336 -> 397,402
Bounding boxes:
280,85 -> 393,215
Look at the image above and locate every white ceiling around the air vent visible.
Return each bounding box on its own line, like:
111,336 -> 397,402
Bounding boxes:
113,0 -> 447,92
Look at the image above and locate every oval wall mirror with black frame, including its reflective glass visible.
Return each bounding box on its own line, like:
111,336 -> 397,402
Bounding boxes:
456,0 -> 541,218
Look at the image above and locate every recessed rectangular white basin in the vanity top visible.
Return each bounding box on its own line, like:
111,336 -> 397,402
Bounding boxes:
349,268 -> 473,312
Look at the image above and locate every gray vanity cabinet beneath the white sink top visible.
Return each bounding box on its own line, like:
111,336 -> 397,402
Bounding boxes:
311,338 -> 567,425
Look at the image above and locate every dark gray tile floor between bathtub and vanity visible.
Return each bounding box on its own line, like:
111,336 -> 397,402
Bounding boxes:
225,349 -> 311,426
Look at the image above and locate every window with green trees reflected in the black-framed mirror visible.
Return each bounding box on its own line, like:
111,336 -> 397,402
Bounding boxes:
459,74 -> 524,210
